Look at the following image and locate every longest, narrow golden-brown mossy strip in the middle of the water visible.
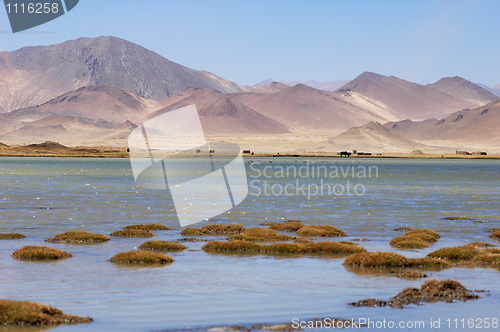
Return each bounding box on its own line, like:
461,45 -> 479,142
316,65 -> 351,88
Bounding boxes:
202,241 -> 366,254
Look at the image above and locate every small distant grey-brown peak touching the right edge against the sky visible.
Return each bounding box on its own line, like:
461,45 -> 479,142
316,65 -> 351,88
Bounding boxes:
427,76 -> 500,107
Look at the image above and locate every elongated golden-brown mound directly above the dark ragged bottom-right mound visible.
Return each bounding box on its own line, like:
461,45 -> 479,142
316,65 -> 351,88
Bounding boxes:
344,252 -> 450,268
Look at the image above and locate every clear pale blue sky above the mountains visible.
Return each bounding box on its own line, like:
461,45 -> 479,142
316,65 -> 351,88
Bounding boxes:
0,0 -> 500,86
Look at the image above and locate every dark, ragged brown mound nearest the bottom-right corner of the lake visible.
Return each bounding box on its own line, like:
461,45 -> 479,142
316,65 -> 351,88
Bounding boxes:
389,279 -> 479,308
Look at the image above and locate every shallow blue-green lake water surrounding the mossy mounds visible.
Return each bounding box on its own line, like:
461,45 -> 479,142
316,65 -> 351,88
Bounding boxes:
0,158 -> 500,331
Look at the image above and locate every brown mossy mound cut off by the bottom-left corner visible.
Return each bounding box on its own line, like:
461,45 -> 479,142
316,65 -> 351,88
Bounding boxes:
0,300 -> 92,326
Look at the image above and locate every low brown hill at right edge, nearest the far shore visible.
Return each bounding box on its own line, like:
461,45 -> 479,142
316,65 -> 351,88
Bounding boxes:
384,100 -> 500,143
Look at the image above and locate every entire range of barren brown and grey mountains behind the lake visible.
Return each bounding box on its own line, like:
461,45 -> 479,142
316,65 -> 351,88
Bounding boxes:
0,37 -> 500,149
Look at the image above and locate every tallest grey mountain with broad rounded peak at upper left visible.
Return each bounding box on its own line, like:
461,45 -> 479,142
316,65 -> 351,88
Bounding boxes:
0,37 -> 268,112
